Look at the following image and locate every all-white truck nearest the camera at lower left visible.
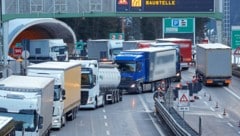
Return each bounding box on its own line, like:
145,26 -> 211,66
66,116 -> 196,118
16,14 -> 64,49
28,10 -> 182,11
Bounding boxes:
0,76 -> 54,136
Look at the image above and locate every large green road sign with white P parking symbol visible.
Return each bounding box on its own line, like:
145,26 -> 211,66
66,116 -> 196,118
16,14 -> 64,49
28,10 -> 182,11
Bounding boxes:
163,18 -> 194,33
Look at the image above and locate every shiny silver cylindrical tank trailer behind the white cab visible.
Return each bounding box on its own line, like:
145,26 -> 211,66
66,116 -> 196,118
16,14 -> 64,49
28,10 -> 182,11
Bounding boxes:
99,62 -> 122,103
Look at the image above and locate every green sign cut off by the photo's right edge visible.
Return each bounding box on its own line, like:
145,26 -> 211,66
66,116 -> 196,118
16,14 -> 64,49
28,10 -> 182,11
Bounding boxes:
231,27 -> 240,49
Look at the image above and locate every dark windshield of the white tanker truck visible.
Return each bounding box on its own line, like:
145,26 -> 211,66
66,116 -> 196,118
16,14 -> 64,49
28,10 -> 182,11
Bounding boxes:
81,73 -> 93,88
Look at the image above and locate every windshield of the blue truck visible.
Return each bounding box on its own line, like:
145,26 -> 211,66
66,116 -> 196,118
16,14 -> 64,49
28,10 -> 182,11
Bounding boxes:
117,62 -> 136,72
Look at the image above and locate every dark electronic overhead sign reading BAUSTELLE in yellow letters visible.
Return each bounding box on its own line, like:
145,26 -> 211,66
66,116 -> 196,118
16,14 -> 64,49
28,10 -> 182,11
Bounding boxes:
116,0 -> 214,13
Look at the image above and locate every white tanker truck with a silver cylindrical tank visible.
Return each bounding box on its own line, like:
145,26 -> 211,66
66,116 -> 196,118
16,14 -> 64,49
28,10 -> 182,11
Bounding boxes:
70,60 -> 122,109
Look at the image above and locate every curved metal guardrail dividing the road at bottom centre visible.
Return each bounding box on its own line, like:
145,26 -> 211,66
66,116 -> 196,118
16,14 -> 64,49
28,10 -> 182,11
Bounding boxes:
154,98 -> 198,136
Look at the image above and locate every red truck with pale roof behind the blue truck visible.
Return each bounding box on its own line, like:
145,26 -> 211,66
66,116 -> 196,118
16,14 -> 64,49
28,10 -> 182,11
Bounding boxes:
156,38 -> 193,70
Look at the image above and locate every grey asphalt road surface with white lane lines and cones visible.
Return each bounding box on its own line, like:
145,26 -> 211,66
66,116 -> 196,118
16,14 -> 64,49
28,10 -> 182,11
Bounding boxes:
51,67 -> 240,136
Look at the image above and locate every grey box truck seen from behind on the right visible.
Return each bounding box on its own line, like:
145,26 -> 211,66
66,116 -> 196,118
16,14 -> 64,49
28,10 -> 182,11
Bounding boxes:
196,43 -> 232,86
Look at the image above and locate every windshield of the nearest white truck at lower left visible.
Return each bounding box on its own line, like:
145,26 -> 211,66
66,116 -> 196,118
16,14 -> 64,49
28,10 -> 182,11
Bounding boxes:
0,111 -> 37,132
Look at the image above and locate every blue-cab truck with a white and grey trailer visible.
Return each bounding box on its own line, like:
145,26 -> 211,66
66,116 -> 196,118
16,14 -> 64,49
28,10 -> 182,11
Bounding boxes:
114,46 -> 177,93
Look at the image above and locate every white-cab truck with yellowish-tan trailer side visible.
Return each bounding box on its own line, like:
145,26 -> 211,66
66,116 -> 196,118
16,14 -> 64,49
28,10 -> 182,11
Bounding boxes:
27,61 -> 81,129
